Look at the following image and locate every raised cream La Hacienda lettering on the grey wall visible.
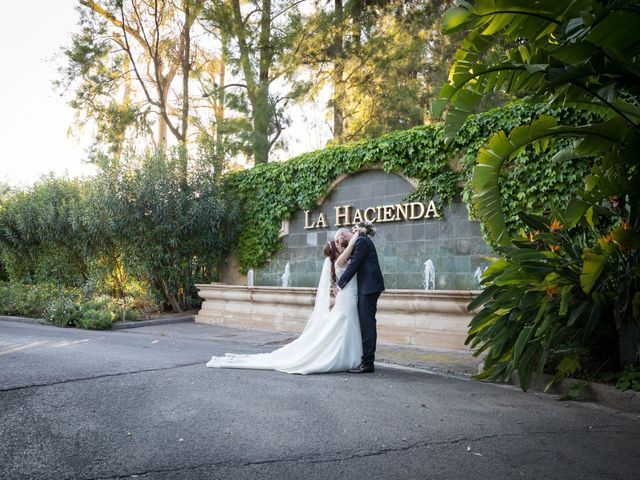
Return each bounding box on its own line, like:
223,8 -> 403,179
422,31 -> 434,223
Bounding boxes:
304,200 -> 440,230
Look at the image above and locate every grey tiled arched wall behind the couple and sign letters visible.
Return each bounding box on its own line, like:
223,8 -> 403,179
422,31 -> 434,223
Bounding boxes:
255,170 -> 491,290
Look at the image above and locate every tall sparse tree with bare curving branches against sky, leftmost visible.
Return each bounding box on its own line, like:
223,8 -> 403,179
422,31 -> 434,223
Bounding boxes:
59,0 -> 206,157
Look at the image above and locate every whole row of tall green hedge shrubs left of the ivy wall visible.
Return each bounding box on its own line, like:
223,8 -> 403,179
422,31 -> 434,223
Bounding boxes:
0,145 -> 235,316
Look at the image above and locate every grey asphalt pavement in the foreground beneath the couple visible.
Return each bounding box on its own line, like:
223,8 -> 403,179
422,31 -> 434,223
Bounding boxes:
0,322 -> 640,480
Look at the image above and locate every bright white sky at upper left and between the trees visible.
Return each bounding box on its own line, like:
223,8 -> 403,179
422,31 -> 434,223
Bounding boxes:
0,0 -> 329,188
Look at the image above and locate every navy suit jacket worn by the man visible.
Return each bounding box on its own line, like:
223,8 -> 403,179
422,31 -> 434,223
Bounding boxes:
338,237 -> 384,295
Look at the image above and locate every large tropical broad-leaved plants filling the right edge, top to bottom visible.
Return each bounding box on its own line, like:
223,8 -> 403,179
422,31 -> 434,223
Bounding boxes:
435,0 -> 640,388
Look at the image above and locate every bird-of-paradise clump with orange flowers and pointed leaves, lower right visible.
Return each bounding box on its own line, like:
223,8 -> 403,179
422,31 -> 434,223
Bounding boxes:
467,207 -> 640,390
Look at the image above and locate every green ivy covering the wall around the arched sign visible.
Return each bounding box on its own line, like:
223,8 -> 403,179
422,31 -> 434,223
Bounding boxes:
225,103 -> 589,272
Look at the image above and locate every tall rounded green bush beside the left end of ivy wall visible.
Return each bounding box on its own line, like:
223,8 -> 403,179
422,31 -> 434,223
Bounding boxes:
101,148 -> 235,311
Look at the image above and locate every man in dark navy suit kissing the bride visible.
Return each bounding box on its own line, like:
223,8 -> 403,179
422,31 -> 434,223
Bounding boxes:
335,227 -> 384,373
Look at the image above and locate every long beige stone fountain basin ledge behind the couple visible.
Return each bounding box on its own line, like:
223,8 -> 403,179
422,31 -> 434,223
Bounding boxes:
196,283 -> 480,350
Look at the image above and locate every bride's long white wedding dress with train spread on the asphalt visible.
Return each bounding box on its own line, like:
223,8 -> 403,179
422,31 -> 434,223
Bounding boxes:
207,258 -> 362,375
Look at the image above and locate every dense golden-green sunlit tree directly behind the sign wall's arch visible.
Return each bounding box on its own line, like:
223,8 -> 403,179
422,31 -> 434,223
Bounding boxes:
298,0 -> 458,143
